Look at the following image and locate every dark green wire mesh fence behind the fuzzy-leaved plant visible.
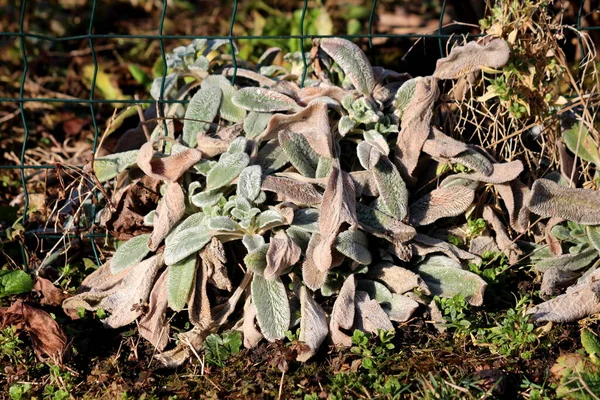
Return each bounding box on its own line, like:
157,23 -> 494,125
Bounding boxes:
0,0 -> 600,267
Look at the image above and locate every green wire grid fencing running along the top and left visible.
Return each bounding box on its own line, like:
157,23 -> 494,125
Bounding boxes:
0,0 -> 600,268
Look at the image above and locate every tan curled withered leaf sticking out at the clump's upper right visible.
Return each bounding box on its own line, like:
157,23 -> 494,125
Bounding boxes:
433,38 -> 510,79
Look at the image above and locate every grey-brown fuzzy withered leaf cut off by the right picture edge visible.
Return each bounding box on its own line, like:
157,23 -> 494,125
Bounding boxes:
527,178 -> 600,225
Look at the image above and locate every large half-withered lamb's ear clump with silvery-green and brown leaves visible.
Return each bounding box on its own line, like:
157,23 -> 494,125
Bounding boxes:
64,38 -> 526,366
